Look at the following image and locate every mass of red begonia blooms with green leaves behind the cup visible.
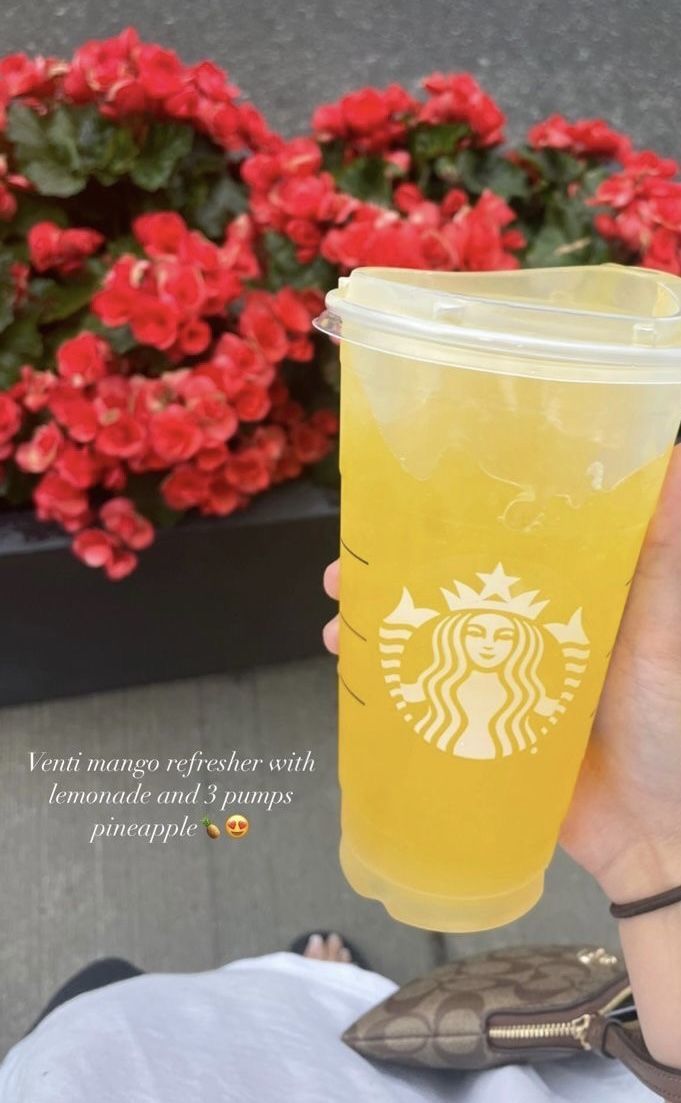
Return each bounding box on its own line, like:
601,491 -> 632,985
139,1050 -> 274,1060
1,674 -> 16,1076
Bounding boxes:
0,30 -> 681,579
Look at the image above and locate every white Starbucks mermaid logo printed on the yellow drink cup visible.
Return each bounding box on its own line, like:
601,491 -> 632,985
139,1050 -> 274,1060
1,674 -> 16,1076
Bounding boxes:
379,564 -> 589,759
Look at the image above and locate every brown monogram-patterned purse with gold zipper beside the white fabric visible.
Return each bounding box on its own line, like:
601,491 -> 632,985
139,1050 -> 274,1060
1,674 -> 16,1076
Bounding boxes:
343,945 -> 681,1103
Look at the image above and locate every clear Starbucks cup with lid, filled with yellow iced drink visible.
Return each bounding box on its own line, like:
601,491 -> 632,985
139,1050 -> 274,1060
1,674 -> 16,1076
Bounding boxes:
318,265 -> 681,931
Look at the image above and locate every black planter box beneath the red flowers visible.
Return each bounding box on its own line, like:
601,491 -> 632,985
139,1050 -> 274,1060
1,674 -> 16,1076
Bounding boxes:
0,481 -> 338,705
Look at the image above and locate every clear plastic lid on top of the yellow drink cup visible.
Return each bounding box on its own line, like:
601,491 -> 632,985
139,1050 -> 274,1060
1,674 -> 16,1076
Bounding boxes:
315,264 -> 681,383
